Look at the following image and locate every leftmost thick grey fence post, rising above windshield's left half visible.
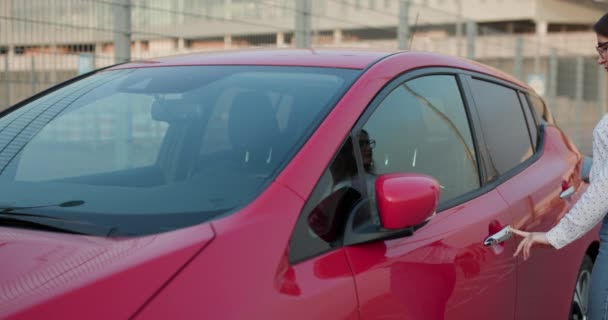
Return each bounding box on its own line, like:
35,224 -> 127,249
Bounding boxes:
113,0 -> 131,63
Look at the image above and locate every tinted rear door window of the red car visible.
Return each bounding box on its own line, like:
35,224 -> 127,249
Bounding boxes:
471,79 -> 533,181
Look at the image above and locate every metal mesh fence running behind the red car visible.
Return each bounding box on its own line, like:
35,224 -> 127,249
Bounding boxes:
0,0 -> 606,153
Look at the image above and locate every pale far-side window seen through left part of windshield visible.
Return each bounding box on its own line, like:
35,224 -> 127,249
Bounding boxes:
16,93 -> 168,181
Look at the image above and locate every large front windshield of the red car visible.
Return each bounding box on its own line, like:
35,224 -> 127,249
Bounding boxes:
0,66 -> 360,235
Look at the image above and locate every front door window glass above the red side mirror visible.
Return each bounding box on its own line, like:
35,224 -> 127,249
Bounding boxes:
362,75 -> 480,203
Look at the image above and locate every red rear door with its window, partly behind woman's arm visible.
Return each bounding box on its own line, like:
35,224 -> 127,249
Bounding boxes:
469,78 -> 586,319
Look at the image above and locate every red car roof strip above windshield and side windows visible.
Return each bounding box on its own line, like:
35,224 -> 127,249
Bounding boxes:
106,48 -> 530,89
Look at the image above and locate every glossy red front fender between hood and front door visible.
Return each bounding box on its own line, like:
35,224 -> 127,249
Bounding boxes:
138,179 -> 357,319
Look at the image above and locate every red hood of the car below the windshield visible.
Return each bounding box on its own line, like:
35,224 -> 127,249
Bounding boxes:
0,224 -> 214,319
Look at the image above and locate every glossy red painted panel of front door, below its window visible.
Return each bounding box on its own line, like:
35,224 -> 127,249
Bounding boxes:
346,191 -> 517,319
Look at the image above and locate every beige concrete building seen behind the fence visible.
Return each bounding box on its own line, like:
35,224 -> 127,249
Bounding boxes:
0,0 -> 602,57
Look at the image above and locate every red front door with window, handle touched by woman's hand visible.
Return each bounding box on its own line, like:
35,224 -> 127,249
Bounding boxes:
345,69 -> 516,320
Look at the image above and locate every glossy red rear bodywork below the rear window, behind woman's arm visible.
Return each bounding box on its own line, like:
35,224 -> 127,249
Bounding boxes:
497,126 -> 599,319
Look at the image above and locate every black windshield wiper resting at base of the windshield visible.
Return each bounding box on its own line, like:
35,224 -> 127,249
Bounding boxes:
0,200 -> 116,236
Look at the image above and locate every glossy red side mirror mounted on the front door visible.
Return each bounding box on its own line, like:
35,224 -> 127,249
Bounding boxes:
376,173 -> 440,229
